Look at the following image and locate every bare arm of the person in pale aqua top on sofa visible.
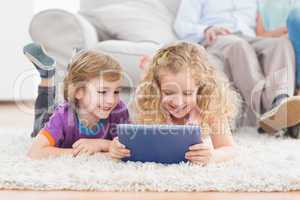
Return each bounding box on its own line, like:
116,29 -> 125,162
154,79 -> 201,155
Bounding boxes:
256,14 -> 288,37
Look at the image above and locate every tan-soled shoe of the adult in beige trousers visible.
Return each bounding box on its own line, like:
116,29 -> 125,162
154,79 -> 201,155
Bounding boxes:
259,96 -> 300,134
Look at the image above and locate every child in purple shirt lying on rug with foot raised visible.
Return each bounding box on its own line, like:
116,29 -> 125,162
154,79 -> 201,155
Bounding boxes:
24,44 -> 129,159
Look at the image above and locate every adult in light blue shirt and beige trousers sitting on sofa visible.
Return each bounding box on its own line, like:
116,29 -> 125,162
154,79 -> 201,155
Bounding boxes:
175,0 -> 300,137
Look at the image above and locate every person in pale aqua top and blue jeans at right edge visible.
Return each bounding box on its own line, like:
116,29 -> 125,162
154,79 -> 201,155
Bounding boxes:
256,0 -> 300,138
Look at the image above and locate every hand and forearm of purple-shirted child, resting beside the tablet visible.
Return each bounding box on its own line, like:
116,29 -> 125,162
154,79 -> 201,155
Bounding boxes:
72,139 -> 112,156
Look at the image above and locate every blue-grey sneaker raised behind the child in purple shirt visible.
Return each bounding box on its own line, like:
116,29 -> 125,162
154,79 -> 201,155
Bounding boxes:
23,43 -> 56,78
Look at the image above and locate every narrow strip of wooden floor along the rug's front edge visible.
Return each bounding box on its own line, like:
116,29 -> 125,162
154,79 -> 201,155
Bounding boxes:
0,191 -> 300,200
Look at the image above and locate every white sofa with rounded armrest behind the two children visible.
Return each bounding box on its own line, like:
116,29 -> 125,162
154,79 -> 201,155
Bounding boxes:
29,0 -> 253,124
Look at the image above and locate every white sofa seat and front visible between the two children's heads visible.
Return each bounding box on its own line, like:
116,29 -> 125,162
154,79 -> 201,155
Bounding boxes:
94,40 -> 160,88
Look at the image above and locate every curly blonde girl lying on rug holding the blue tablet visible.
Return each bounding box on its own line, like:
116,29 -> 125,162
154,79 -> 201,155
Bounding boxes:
111,42 -> 239,165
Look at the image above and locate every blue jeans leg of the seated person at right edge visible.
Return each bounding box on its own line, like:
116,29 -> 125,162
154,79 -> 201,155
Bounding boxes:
287,8 -> 300,89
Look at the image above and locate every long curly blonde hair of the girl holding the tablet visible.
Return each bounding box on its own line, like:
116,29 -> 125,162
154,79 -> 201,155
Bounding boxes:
134,42 -> 240,124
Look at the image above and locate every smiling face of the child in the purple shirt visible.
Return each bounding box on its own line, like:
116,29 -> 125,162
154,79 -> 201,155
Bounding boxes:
76,78 -> 121,119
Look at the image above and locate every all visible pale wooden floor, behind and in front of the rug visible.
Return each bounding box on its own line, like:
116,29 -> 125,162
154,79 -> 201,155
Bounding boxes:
0,102 -> 300,200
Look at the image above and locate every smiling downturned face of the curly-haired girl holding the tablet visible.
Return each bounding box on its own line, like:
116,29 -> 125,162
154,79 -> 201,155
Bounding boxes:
160,71 -> 198,119
